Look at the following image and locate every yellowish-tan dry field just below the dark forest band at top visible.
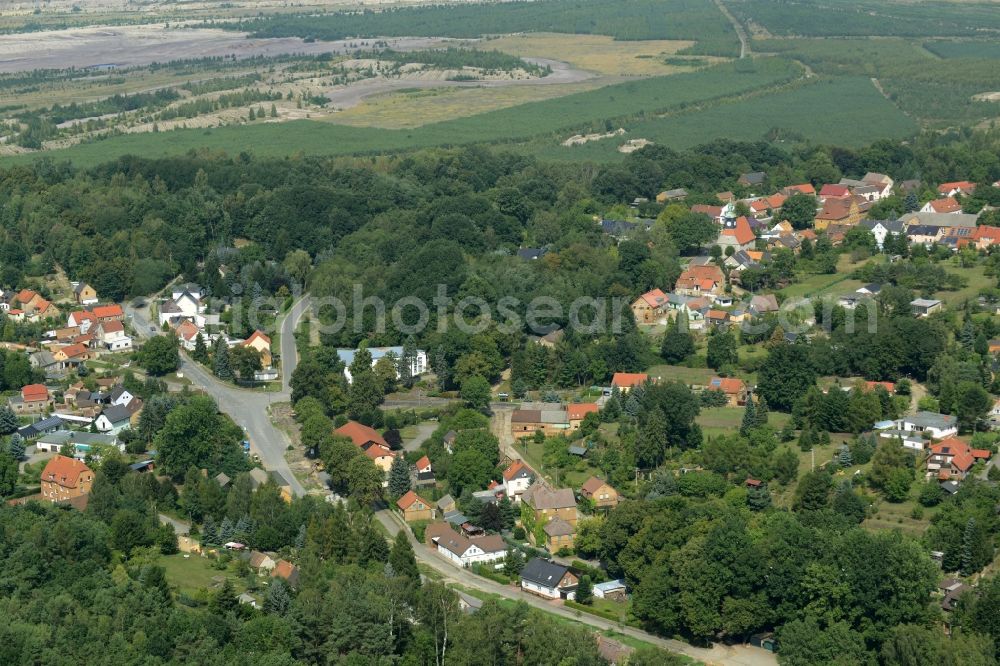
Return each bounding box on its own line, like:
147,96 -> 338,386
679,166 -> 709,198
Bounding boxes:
480,32 -> 700,76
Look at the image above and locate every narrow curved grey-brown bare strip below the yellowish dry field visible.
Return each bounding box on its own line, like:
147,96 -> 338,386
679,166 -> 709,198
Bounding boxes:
326,58 -> 596,109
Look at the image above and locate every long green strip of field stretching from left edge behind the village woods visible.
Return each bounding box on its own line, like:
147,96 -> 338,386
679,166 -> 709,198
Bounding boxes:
0,59 -> 799,164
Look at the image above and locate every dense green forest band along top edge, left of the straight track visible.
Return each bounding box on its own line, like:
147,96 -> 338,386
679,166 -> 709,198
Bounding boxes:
230,0 -> 739,56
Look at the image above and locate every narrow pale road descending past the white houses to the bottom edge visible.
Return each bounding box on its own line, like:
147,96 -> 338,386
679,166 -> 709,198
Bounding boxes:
375,509 -> 778,666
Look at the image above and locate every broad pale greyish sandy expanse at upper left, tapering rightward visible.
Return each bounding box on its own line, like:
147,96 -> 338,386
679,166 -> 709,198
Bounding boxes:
0,24 -> 443,72
